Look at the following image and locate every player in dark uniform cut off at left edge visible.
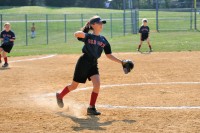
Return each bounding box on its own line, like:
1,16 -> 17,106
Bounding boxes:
0,22 -> 15,68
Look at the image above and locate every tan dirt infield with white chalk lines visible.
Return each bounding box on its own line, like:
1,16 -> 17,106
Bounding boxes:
0,52 -> 200,133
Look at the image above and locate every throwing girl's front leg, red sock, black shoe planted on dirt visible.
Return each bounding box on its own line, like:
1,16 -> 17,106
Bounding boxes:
87,74 -> 101,115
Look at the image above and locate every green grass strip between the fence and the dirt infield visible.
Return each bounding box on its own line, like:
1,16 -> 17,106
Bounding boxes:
10,32 -> 200,56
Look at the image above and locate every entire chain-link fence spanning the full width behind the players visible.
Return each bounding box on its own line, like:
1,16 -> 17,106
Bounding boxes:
0,9 -> 200,45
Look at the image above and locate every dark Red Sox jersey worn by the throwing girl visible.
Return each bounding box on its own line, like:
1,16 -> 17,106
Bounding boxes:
78,33 -> 112,59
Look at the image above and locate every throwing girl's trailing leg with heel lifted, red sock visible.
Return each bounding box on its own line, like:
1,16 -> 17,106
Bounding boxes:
56,81 -> 79,108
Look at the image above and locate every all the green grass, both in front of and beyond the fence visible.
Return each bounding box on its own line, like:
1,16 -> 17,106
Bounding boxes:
0,7 -> 200,56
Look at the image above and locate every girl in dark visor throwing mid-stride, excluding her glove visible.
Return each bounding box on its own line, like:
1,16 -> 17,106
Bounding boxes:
56,16 -> 130,115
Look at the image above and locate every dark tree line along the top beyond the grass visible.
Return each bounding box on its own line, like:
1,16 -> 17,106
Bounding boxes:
0,0 -> 200,9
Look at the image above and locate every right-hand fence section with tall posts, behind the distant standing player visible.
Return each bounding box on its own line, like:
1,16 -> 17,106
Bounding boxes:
139,8 -> 200,31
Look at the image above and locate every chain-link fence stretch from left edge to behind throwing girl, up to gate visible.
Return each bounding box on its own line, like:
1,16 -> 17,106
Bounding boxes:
0,12 -> 137,45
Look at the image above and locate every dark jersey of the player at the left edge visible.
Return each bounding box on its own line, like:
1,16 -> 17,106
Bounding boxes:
0,30 -> 15,45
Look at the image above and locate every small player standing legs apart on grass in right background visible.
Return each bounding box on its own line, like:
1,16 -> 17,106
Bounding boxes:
137,18 -> 152,52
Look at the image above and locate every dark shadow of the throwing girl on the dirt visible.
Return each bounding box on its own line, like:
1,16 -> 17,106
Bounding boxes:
56,112 -> 136,131
